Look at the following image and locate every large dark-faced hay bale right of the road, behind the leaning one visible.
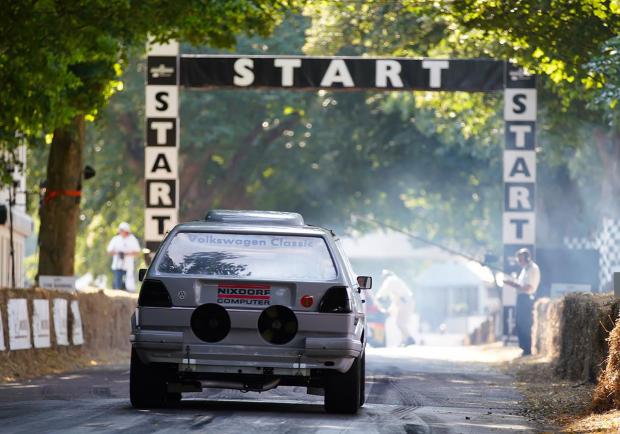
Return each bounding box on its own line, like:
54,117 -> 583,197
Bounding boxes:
554,293 -> 619,382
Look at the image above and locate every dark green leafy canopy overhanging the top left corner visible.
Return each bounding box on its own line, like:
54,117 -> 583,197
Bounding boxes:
0,0 -> 300,154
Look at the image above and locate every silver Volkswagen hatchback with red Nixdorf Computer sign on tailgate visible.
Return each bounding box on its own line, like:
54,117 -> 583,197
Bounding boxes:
130,210 -> 372,413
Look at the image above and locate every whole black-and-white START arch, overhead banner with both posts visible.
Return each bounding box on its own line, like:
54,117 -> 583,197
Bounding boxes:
144,53 -> 537,282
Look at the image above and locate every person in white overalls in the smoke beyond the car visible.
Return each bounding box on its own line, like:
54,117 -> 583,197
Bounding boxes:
374,270 -> 415,345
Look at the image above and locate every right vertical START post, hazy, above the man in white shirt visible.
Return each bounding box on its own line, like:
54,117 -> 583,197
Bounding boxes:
502,62 -> 537,282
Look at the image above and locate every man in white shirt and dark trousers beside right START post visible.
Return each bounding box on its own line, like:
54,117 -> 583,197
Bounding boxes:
512,248 -> 540,356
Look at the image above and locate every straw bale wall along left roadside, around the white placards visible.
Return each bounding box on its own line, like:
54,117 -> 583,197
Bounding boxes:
0,288 -> 137,381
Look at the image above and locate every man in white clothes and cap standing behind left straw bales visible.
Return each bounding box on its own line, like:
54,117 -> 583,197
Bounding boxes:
107,222 -> 140,292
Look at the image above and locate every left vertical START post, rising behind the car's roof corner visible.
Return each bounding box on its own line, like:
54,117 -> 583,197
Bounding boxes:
144,41 -> 180,251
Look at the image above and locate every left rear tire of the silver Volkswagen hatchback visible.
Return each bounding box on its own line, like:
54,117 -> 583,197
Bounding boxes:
129,348 -> 168,409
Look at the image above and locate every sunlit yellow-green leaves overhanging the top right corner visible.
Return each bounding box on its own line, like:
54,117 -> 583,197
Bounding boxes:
449,0 -> 620,96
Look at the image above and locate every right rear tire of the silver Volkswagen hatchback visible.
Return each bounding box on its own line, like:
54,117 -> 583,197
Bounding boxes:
325,357 -> 362,414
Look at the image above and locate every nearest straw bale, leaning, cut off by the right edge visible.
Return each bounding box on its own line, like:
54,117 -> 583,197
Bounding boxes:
592,316 -> 620,412
